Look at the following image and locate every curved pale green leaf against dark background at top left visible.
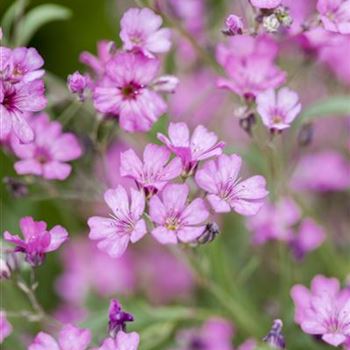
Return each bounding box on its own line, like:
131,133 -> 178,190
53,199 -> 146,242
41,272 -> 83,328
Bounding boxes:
17,4 -> 72,45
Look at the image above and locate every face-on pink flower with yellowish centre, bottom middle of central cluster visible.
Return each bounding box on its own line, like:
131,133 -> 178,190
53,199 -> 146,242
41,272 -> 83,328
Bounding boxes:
149,184 -> 209,244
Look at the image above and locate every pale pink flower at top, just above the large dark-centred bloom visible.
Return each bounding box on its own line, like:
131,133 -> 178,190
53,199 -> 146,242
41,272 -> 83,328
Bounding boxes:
120,8 -> 171,57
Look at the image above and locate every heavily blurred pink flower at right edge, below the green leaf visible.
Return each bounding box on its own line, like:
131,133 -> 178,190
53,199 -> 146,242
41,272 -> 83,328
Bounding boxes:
291,150 -> 350,192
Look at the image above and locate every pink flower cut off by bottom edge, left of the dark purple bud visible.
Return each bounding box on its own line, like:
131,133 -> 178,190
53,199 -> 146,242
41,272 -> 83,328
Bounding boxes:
28,324 -> 91,350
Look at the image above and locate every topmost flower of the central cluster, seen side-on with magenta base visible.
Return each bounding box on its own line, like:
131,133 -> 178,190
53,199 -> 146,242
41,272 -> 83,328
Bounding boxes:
157,123 -> 225,173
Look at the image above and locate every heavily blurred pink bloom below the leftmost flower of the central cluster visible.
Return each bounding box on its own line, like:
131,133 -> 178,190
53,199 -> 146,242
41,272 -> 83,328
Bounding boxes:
56,239 -> 136,305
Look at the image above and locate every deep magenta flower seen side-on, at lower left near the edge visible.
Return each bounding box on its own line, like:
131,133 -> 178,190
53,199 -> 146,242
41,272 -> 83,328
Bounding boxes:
4,216 -> 68,266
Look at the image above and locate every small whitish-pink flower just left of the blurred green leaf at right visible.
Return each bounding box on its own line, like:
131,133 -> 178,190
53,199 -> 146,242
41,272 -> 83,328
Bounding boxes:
256,88 -> 301,130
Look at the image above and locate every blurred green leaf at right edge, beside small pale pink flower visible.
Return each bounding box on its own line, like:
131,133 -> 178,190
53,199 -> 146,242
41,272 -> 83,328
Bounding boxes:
296,96 -> 350,126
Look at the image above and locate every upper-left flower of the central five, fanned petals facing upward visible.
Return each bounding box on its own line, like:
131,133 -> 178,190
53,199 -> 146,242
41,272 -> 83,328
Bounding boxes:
120,144 -> 182,196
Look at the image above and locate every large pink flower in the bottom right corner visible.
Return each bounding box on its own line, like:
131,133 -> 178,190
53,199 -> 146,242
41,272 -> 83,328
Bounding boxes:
291,276 -> 350,346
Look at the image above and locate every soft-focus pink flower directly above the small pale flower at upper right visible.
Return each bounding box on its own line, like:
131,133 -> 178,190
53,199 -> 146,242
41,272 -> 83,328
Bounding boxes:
218,56 -> 286,98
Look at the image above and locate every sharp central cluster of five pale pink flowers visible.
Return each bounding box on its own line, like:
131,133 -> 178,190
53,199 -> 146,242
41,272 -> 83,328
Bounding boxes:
88,123 -> 268,257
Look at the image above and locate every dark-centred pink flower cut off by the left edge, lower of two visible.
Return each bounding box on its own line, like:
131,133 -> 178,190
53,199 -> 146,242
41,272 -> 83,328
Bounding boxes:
0,80 -> 47,143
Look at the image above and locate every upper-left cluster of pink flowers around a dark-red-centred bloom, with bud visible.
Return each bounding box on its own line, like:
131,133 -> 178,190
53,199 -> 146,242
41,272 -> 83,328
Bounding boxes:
68,8 -> 178,132
